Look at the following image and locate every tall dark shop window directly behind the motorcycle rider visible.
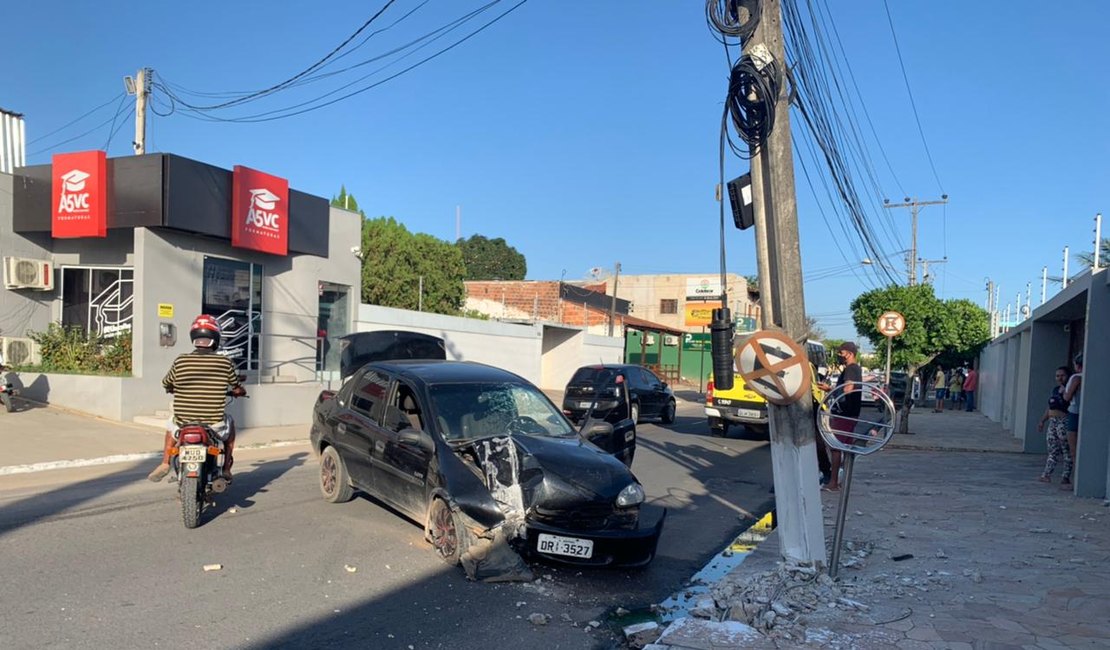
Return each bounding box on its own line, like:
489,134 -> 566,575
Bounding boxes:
201,257 -> 262,370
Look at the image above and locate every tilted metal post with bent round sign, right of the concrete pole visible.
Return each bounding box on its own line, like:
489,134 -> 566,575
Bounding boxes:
817,383 -> 895,578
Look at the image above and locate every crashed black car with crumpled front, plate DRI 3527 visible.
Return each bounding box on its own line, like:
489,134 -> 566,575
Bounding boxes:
311,360 -> 666,577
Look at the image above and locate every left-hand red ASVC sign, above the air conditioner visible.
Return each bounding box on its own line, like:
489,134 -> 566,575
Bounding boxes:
50,151 -> 108,238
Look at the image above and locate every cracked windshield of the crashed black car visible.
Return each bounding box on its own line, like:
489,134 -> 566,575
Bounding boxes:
428,383 -> 577,441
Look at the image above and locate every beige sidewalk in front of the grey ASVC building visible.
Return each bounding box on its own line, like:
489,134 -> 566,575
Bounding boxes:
0,400 -> 309,476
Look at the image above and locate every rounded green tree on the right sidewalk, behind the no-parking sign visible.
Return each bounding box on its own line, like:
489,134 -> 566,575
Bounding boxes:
851,284 -> 990,434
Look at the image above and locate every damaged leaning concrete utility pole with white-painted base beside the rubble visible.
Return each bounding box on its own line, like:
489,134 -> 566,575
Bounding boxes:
744,0 -> 826,566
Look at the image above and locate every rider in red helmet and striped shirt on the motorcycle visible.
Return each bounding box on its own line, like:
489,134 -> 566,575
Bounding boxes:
147,314 -> 246,483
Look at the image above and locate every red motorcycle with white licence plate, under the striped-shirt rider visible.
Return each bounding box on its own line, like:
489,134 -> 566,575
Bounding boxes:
171,388 -> 246,528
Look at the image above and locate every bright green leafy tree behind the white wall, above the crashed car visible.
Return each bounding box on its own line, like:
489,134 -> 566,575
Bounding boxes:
362,216 -> 466,315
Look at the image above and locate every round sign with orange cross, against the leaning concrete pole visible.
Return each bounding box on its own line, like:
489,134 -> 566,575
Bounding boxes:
736,329 -> 813,406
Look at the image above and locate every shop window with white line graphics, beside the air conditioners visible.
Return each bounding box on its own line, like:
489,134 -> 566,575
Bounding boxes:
61,266 -> 134,337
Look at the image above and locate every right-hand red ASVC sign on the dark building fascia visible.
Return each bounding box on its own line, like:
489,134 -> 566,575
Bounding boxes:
231,165 -> 289,255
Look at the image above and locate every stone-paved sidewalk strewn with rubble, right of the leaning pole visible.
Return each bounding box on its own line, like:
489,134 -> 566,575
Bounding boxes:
647,412 -> 1110,650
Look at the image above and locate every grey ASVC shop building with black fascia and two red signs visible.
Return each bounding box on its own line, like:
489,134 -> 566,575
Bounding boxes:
0,152 -> 361,426
